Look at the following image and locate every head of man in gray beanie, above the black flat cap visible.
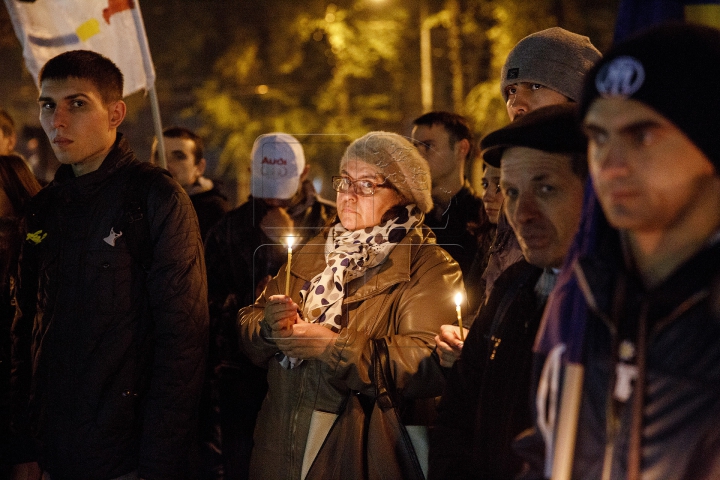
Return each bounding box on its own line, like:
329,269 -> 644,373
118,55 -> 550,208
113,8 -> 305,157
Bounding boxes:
500,27 -> 601,120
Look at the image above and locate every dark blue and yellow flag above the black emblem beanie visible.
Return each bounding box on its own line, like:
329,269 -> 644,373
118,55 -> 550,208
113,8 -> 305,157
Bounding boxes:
615,0 -> 720,42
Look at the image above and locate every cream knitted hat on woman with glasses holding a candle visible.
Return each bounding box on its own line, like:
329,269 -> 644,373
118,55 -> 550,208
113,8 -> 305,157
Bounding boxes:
340,132 -> 433,213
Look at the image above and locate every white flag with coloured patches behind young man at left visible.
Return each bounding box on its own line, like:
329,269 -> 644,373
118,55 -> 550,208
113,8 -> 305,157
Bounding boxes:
5,0 -> 155,96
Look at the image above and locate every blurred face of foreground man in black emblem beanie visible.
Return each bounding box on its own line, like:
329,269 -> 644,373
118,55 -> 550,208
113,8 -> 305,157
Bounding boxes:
584,99 -> 718,233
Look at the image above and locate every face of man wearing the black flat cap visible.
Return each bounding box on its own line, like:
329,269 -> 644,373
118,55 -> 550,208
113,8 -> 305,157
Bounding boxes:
500,147 -> 583,268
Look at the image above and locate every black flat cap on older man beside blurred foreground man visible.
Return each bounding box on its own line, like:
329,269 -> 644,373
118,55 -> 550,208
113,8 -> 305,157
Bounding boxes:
480,102 -> 587,168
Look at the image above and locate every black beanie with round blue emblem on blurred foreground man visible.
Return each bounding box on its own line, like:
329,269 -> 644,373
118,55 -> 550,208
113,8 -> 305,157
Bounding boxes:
580,23 -> 720,172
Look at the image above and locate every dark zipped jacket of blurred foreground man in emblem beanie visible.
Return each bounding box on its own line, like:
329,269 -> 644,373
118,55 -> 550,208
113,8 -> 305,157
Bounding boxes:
517,219 -> 720,480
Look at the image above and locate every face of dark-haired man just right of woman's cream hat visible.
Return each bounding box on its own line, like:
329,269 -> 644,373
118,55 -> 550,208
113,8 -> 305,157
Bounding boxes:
412,123 -> 463,181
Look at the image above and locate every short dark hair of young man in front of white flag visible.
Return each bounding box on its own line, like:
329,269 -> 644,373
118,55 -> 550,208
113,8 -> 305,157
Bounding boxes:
40,50 -> 123,105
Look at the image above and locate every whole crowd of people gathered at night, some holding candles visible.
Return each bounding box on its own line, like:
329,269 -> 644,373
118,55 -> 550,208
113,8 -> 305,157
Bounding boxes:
0,20 -> 720,480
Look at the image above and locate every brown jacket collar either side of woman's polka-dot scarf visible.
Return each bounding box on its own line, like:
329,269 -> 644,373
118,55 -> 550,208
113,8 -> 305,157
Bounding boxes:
291,224 -> 435,303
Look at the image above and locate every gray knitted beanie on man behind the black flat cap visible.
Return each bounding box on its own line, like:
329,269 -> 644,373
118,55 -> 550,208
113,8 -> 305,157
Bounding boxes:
500,27 -> 602,102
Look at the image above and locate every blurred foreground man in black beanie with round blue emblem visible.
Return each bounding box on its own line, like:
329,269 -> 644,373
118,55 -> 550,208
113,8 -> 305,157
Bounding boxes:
528,24 -> 720,480
